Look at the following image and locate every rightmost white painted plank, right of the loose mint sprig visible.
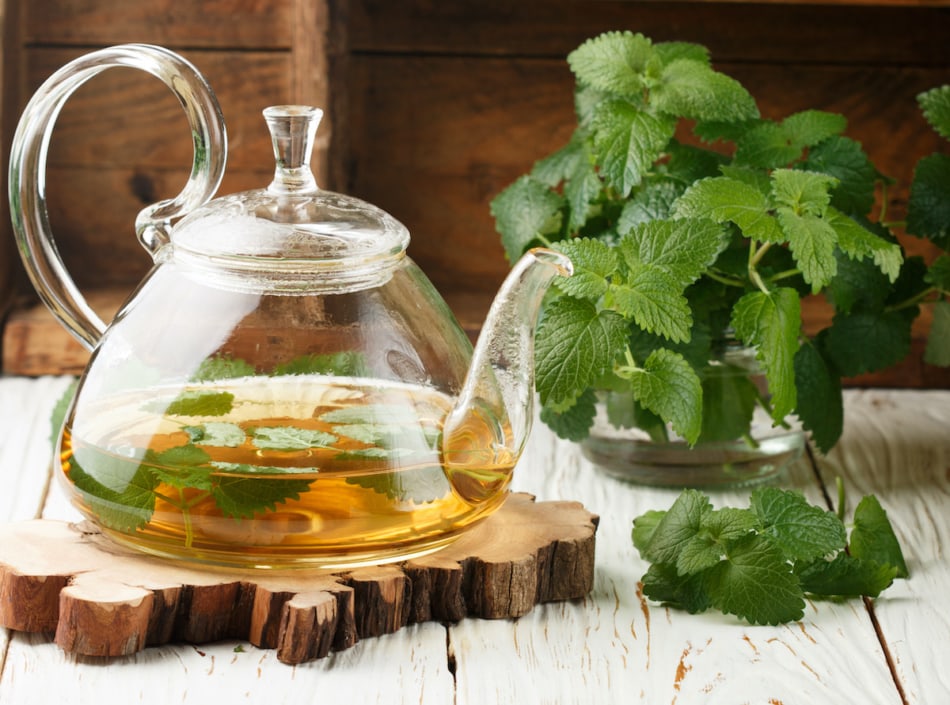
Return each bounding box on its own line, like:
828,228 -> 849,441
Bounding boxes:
820,390 -> 950,705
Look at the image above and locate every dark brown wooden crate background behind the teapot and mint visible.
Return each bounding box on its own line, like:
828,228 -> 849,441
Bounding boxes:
0,0 -> 950,386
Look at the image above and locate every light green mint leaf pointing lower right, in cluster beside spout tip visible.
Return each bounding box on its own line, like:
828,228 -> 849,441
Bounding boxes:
608,266 -> 693,342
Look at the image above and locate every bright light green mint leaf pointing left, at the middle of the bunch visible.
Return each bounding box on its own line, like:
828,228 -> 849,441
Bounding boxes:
674,176 -> 785,242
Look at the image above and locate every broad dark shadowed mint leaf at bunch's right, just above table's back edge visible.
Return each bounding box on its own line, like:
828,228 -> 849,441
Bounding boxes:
823,311 -> 913,377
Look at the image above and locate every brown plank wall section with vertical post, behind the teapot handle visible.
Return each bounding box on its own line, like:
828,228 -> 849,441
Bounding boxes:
0,0 -> 342,324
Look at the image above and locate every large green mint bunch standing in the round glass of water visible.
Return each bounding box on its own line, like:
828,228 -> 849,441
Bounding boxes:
491,32 -> 950,451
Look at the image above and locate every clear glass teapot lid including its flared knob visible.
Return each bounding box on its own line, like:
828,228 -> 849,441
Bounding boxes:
170,105 -> 409,289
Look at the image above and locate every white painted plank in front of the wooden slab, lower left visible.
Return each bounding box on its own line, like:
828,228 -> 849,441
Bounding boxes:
0,624 -> 453,705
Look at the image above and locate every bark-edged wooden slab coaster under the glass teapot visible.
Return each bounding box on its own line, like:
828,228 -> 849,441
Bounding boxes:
0,494 -> 598,664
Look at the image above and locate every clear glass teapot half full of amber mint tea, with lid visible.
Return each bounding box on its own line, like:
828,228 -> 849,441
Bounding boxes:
10,45 -> 570,568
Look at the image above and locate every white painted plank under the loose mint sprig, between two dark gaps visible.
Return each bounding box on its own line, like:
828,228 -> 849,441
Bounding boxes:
450,402 -> 900,705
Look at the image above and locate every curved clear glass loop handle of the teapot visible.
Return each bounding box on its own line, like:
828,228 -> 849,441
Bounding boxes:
9,44 -> 227,350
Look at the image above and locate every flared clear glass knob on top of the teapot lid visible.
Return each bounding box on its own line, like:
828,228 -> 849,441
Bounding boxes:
264,105 -> 323,194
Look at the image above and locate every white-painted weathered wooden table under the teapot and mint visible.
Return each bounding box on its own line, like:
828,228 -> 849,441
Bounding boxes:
0,377 -> 950,705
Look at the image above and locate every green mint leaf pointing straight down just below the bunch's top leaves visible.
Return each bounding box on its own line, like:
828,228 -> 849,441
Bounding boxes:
592,100 -> 676,197
